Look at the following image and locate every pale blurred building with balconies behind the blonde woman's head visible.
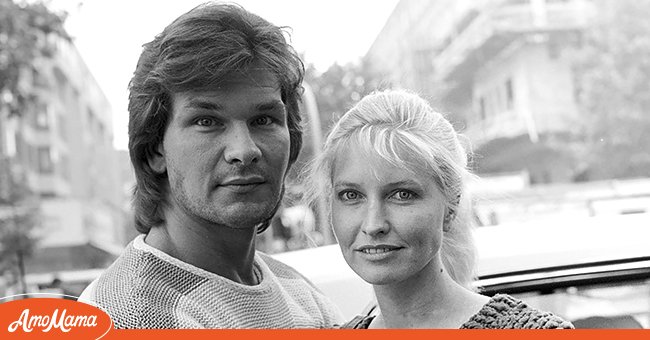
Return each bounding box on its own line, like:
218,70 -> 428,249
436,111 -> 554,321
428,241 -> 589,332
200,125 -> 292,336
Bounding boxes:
365,0 -> 594,183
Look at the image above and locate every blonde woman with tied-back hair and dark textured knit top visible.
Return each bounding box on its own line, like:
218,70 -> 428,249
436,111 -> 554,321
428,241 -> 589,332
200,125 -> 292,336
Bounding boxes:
309,91 -> 573,328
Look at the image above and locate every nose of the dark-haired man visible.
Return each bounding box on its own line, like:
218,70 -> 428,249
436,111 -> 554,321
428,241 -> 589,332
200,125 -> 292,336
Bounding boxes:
224,123 -> 262,165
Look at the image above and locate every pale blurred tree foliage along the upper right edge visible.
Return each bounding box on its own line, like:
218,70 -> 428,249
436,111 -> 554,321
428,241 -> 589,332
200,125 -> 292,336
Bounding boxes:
575,0 -> 650,179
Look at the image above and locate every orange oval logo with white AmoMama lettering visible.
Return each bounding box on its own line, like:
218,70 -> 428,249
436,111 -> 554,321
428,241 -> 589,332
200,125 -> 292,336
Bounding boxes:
0,298 -> 113,339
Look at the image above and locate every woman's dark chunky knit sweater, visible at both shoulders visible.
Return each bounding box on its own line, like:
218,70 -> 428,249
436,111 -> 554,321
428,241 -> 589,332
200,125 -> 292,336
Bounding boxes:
341,294 -> 573,329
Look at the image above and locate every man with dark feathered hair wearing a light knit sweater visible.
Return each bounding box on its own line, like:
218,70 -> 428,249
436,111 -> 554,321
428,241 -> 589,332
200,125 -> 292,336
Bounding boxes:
80,3 -> 340,328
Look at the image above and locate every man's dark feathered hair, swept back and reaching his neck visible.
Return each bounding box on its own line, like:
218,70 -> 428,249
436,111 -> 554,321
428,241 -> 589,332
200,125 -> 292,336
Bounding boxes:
129,3 -> 304,233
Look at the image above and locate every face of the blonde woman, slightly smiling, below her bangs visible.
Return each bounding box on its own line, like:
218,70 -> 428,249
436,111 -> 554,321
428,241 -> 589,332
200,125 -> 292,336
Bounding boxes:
331,147 -> 445,284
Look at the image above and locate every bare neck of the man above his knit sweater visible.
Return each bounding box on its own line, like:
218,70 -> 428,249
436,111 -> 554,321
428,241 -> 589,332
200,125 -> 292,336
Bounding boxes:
145,216 -> 259,285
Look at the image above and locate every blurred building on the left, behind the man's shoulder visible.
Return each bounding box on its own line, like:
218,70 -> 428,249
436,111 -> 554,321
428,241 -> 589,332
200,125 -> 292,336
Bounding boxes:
0,35 -> 125,290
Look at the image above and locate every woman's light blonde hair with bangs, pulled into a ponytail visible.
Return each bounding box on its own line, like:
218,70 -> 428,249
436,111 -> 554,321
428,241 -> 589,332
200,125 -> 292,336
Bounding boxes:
305,90 -> 476,289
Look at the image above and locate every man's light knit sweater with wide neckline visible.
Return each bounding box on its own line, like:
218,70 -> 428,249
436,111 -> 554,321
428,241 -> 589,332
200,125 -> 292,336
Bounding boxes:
79,235 -> 340,328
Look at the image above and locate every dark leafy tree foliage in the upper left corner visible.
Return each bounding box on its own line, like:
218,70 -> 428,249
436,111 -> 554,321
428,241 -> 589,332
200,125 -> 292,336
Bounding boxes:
0,0 -> 69,115
